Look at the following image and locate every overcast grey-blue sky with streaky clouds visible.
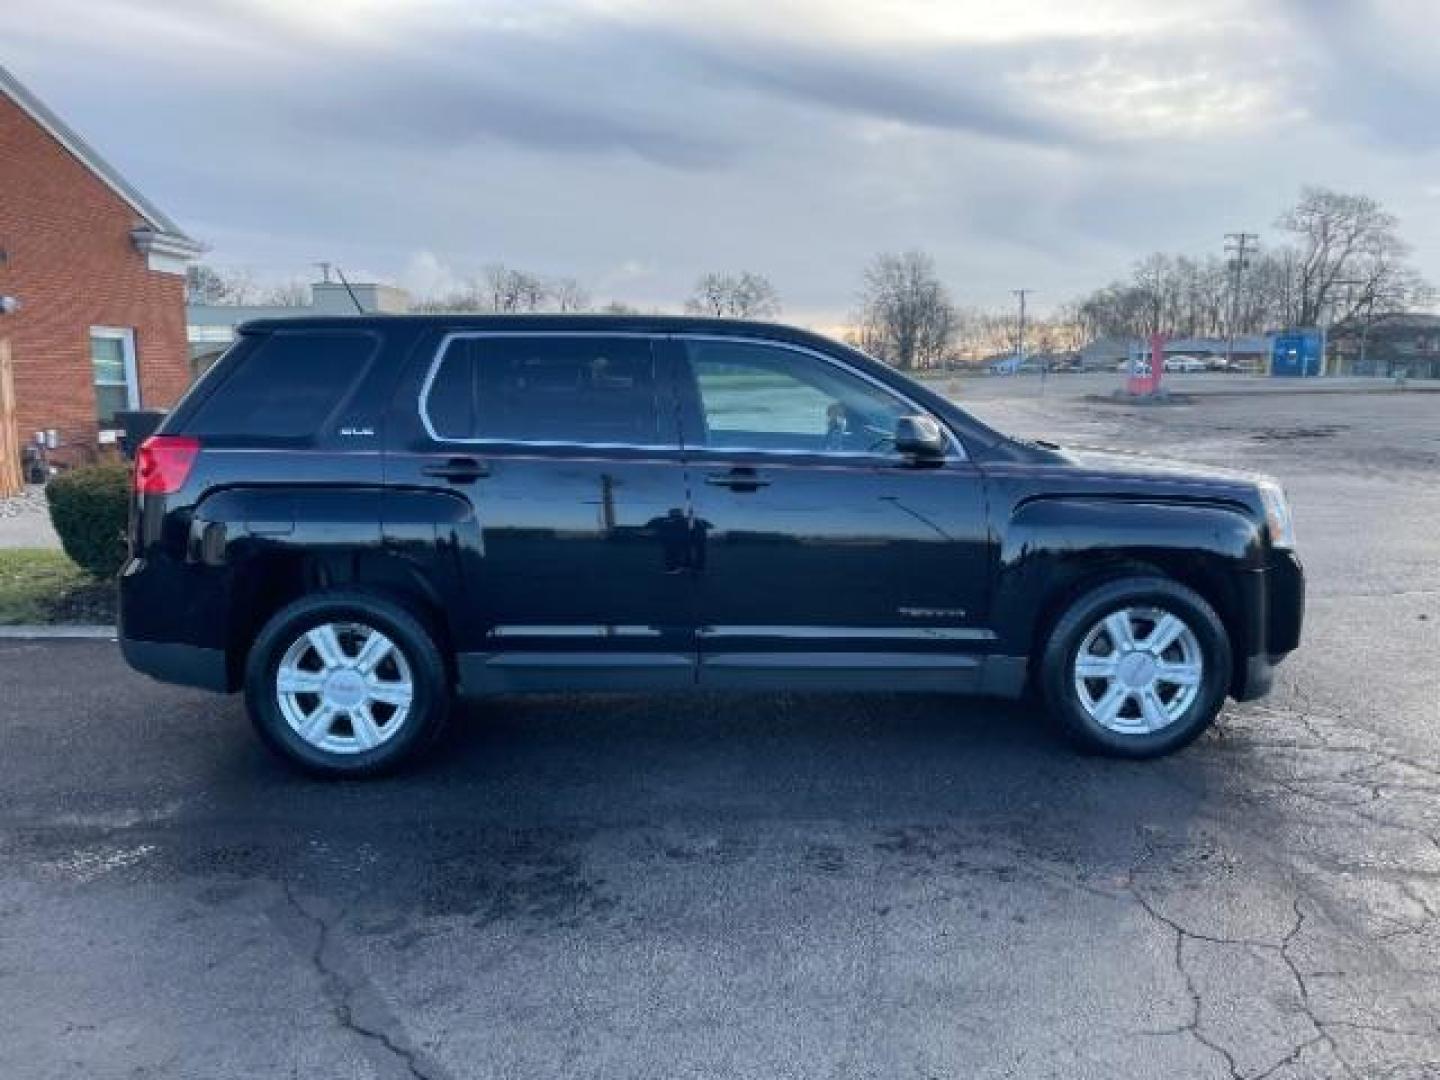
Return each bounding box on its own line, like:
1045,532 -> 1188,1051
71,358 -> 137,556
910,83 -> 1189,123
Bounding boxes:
0,0 -> 1440,324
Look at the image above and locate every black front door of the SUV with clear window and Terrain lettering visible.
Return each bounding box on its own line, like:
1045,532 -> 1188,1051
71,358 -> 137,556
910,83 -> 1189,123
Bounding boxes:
670,337 -> 994,688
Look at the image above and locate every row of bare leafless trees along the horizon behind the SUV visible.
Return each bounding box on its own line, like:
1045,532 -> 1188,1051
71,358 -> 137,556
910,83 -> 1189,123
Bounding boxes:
190,187 -> 1434,370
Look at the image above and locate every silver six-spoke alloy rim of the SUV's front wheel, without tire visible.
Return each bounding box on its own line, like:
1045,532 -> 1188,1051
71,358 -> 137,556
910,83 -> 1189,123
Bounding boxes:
1074,608 -> 1205,734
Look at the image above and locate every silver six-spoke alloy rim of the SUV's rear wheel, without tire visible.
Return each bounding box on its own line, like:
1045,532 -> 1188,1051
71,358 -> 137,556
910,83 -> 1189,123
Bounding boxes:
275,622 -> 415,753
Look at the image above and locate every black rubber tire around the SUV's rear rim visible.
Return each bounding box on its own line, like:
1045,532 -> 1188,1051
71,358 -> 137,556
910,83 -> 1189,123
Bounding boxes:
245,590 -> 451,778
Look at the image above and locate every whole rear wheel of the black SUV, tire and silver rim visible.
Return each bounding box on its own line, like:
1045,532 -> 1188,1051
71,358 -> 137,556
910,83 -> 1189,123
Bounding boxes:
245,592 -> 449,776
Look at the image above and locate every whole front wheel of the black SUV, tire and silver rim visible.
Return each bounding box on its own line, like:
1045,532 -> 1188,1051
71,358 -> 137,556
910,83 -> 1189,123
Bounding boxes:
1041,576 -> 1231,757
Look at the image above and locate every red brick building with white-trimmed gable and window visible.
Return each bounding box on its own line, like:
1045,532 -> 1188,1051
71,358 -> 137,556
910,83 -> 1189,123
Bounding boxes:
0,66 -> 200,464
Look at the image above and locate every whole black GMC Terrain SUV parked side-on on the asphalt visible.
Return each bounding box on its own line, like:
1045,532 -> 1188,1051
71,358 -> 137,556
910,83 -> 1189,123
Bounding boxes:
121,317 -> 1303,775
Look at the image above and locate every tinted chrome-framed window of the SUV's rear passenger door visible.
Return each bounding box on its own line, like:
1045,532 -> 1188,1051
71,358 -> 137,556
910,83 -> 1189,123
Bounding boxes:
422,336 -> 659,446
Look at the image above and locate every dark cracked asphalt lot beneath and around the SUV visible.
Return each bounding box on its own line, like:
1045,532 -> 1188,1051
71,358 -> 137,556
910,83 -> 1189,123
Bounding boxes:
0,379 -> 1440,1080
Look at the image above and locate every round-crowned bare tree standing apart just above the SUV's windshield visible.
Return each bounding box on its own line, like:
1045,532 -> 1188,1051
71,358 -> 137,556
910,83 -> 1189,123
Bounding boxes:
858,251 -> 959,372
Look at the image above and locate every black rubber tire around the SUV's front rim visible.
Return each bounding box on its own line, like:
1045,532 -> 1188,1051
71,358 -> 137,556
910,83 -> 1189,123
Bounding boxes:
1040,575 -> 1231,759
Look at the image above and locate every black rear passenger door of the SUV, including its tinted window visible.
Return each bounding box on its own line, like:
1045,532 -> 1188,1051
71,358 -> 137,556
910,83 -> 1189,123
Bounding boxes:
386,331 -> 696,691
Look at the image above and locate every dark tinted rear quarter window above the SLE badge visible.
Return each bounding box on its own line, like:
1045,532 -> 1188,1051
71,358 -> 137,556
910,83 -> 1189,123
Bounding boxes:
186,330 -> 377,439
